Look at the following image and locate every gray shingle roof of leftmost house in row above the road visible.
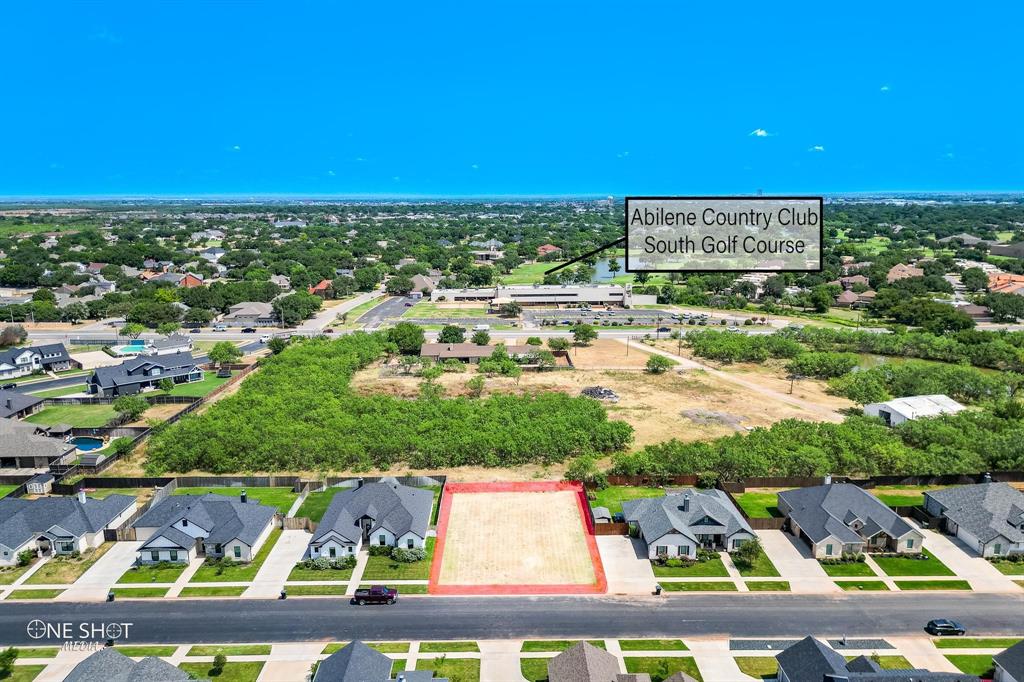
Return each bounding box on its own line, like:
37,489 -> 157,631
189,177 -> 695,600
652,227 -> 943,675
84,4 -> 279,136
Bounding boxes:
0,495 -> 135,549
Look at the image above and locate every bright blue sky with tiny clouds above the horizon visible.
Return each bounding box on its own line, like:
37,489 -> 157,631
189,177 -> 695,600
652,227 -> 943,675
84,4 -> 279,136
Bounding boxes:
0,2 -> 1024,197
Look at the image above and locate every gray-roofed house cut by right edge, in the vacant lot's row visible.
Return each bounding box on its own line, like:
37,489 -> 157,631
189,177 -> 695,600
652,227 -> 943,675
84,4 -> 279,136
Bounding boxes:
925,483 -> 1024,556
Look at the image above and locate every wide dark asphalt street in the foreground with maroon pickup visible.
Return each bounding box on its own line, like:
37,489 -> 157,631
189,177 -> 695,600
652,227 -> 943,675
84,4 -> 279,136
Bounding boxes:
0,593 -> 1024,645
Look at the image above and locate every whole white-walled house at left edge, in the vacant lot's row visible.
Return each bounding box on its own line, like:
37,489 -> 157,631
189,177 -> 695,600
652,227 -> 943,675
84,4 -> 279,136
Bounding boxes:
0,492 -> 135,566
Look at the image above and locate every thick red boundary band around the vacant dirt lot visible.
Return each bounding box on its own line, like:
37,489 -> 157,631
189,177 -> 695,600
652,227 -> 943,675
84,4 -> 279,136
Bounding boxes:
428,481 -> 608,595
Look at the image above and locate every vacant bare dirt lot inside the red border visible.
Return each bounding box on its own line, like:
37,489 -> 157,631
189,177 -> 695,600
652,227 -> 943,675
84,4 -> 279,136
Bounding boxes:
437,491 -> 596,586
